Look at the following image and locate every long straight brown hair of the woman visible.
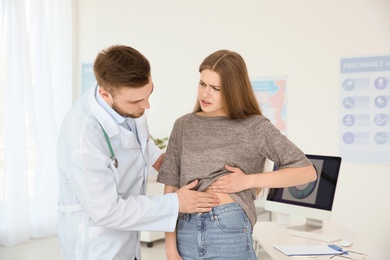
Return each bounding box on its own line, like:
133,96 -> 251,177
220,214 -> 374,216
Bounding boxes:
194,50 -> 262,119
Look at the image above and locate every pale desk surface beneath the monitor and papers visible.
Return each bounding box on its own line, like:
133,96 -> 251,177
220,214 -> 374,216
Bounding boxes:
253,221 -> 389,260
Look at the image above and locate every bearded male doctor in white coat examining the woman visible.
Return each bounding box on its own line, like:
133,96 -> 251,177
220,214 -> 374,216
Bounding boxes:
57,46 -> 219,260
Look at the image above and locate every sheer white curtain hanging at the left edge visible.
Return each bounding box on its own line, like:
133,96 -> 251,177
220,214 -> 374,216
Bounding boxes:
0,0 -> 72,245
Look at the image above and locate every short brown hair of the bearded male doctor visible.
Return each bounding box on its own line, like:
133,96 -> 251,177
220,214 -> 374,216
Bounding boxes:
93,45 -> 150,94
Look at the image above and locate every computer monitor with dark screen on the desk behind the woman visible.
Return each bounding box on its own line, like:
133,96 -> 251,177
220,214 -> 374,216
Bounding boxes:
264,154 -> 341,231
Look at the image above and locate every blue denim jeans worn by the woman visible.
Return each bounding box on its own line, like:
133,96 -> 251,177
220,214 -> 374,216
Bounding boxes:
176,202 -> 257,260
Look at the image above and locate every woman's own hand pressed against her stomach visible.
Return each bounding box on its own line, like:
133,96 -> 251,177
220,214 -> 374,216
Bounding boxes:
207,165 -> 250,193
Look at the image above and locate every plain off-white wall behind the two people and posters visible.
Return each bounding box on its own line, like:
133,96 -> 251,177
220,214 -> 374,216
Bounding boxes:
75,0 -> 390,253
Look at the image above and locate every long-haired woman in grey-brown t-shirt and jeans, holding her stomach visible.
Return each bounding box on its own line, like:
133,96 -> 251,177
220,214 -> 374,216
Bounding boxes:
157,50 -> 316,260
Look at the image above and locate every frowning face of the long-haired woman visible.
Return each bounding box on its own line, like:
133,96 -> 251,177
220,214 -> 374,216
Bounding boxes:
198,69 -> 226,116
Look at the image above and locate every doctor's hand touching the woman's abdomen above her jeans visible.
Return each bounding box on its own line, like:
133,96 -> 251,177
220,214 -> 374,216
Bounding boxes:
176,180 -> 220,213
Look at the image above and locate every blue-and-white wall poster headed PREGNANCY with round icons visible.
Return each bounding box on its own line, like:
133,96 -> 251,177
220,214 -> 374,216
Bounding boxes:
339,55 -> 390,164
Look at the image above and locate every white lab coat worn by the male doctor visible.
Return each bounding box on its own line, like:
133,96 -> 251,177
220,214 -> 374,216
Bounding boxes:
58,88 -> 179,260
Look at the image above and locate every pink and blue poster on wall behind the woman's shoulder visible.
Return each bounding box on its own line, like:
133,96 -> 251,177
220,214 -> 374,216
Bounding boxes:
251,77 -> 287,135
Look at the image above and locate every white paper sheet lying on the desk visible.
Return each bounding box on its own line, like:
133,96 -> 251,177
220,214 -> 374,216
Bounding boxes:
274,245 -> 342,256
